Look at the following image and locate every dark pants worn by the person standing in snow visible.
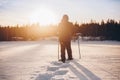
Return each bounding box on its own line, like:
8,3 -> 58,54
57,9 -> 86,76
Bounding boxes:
60,41 -> 72,60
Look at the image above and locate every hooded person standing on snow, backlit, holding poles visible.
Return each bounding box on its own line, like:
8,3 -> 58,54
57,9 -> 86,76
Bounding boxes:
58,15 -> 74,63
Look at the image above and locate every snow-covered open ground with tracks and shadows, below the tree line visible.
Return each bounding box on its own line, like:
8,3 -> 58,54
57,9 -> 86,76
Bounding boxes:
0,40 -> 120,80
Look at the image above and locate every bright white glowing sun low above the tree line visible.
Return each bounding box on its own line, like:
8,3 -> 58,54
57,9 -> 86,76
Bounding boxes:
30,7 -> 57,26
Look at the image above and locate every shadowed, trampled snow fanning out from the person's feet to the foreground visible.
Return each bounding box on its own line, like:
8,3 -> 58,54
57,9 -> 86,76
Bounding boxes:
35,60 -> 101,80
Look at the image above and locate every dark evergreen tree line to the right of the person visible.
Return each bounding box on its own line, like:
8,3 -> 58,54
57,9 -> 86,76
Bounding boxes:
77,19 -> 120,41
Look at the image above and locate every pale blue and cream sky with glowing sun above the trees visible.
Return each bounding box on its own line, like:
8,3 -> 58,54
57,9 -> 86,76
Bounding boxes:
0,0 -> 120,25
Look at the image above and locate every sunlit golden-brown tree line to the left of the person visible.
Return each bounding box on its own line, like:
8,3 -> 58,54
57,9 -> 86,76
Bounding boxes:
0,24 -> 56,41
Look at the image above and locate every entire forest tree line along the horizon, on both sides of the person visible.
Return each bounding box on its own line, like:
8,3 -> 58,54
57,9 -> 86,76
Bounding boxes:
0,19 -> 120,41
